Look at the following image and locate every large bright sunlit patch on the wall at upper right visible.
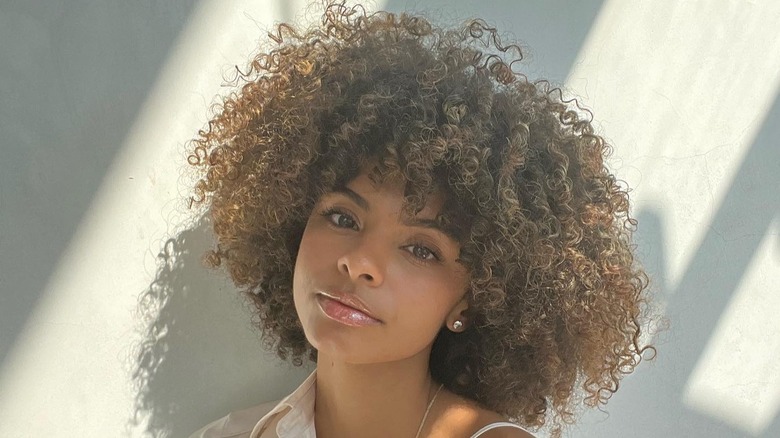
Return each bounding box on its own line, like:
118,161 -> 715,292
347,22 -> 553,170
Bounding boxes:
566,0 -> 780,292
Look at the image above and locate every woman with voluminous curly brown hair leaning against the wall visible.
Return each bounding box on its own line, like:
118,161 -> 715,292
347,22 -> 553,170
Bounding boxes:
190,2 -> 650,438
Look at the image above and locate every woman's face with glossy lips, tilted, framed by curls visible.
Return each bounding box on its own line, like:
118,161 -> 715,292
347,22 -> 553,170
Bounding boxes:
293,170 -> 468,363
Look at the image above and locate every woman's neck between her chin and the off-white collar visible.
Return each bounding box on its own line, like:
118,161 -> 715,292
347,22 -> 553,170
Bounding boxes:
314,351 -> 438,438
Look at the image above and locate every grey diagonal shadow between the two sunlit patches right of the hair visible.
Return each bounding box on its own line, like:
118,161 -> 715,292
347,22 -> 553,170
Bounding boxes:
577,90 -> 780,438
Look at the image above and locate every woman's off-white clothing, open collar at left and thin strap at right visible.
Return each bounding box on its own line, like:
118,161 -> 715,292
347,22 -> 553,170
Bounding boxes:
190,371 -> 530,438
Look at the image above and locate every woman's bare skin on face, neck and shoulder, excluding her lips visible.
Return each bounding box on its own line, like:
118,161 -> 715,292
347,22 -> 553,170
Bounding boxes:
293,167 -> 530,438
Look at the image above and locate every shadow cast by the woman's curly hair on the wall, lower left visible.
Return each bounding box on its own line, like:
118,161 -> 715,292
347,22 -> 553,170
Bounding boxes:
128,220 -> 309,438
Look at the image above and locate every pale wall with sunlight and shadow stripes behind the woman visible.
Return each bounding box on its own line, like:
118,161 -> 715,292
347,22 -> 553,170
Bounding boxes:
0,0 -> 780,437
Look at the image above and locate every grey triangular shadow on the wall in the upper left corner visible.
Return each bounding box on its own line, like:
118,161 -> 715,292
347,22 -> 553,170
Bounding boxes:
0,0 -> 197,367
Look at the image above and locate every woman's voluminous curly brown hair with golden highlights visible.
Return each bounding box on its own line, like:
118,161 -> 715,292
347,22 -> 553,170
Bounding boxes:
189,1 -> 652,432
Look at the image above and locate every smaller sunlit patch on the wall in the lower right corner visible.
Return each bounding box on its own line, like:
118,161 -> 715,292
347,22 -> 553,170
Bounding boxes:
683,219 -> 780,436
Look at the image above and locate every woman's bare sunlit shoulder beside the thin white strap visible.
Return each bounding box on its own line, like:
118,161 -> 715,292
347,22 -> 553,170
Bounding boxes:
430,391 -> 534,438
